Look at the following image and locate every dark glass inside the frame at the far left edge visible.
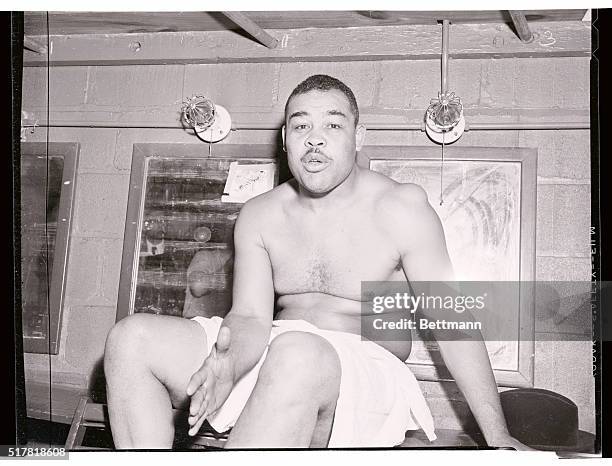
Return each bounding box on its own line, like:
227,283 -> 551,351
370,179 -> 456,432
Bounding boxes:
21,156 -> 64,340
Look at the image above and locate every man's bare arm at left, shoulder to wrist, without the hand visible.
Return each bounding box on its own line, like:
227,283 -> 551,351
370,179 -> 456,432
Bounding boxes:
216,198 -> 274,383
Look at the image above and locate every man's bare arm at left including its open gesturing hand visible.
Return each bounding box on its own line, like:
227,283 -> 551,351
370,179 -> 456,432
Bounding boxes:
187,199 -> 274,435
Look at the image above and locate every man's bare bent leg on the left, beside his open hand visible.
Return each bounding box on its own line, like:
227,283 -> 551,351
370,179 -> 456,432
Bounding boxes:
104,314 -> 207,449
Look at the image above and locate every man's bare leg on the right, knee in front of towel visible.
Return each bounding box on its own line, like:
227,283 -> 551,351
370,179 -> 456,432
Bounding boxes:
226,332 -> 341,448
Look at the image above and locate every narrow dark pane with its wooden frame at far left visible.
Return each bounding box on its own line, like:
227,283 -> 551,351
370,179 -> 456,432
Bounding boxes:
20,142 -> 79,354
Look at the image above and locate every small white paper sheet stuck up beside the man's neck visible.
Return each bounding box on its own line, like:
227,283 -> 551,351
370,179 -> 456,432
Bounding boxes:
221,162 -> 276,203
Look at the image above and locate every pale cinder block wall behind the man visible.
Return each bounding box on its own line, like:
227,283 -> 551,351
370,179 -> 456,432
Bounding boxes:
23,58 -> 595,432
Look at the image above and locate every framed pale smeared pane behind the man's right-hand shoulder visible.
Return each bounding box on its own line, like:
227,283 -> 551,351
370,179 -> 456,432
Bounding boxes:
358,146 -> 537,387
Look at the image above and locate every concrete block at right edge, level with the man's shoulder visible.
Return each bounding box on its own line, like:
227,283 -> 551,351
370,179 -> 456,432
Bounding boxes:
554,185 -> 591,257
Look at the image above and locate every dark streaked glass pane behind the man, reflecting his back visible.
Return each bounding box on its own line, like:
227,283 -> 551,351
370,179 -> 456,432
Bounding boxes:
133,157 -> 278,317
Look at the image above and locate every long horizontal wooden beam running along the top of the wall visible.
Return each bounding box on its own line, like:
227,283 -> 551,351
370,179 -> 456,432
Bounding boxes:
24,21 -> 591,66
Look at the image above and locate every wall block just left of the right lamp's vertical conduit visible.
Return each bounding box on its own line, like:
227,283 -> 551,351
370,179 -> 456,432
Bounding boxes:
377,60 -> 440,110
